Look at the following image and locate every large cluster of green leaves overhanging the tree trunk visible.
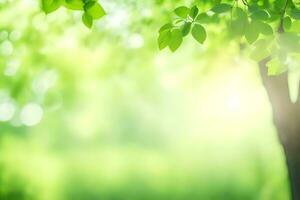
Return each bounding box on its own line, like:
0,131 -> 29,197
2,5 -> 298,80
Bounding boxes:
158,0 -> 300,75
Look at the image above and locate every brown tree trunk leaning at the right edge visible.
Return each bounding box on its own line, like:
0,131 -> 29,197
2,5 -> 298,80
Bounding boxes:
259,57 -> 300,200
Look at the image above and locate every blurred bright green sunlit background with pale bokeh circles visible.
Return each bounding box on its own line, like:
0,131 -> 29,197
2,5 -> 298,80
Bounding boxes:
0,0 -> 289,200
